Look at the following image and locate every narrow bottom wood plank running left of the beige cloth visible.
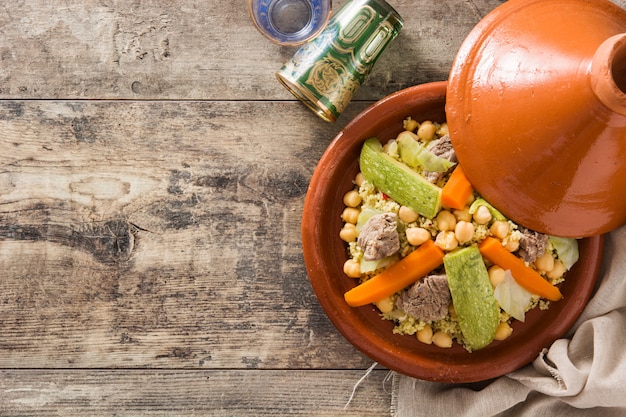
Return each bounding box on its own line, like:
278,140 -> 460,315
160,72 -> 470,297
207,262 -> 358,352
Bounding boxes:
0,370 -> 391,417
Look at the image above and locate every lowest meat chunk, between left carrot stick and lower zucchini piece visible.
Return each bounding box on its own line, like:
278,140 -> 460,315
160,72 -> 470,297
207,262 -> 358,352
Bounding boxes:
396,274 -> 452,321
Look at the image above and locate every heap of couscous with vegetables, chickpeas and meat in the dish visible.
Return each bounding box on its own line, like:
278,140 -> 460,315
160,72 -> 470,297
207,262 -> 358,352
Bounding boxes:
339,118 -> 578,351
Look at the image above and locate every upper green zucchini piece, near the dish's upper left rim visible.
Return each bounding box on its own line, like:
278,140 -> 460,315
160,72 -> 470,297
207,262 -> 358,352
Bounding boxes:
359,138 -> 441,219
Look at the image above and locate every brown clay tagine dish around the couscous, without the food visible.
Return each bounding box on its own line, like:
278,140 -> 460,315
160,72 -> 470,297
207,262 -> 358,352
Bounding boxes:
302,82 -> 603,383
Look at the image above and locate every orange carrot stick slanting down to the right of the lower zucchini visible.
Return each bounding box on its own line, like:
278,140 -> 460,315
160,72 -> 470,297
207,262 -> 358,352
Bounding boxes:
478,237 -> 563,301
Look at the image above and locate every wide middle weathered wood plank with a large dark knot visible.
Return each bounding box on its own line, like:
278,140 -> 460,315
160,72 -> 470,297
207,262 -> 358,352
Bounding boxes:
0,101 -> 376,368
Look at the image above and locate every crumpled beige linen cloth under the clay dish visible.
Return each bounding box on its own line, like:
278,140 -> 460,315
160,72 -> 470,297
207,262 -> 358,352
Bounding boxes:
391,226 -> 626,417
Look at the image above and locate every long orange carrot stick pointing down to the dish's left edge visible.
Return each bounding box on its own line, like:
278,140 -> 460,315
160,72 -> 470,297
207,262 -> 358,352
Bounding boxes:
344,240 -> 443,307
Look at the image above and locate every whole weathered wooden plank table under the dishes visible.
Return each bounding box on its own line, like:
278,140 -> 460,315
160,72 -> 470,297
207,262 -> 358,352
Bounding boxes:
0,0 -> 624,416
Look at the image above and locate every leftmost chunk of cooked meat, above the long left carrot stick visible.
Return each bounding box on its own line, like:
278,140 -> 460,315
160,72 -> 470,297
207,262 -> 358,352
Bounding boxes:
357,213 -> 400,261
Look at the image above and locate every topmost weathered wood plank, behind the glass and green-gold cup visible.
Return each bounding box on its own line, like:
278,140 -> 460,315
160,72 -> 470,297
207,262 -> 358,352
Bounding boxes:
0,0 -> 512,100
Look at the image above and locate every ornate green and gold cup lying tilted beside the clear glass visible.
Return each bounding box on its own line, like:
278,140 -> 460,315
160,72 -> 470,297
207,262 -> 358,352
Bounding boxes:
276,0 -> 404,122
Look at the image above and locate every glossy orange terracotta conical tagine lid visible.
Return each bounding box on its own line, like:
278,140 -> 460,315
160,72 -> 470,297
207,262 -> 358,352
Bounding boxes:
446,0 -> 626,237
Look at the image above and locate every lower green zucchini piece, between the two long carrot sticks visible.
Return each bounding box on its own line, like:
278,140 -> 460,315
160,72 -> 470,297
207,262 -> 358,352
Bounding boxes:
443,246 -> 500,350
